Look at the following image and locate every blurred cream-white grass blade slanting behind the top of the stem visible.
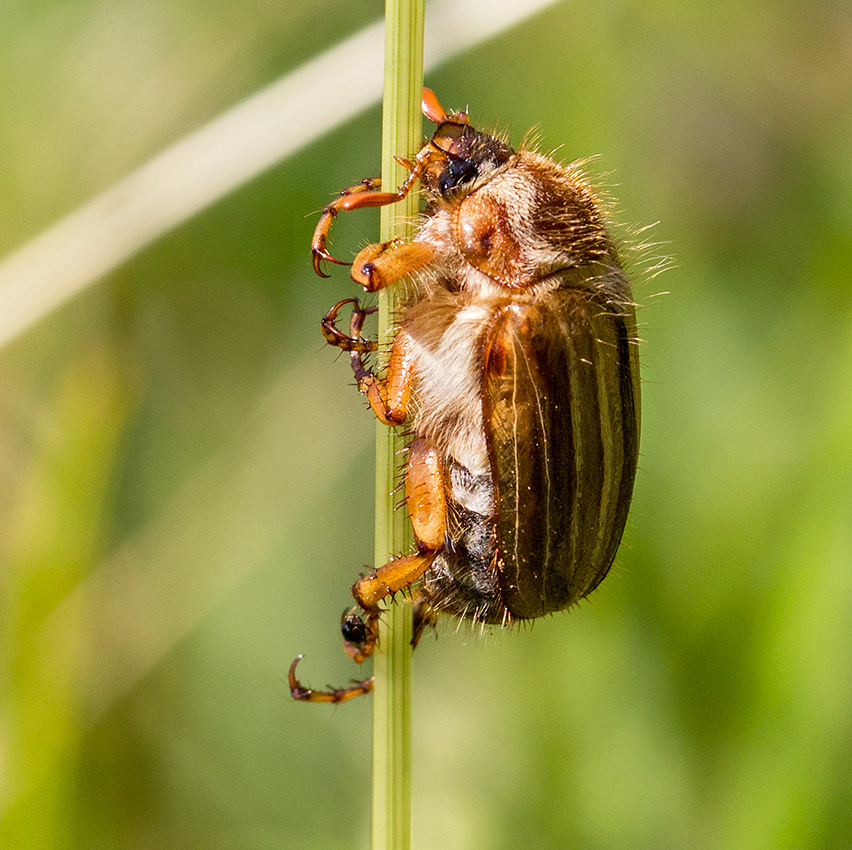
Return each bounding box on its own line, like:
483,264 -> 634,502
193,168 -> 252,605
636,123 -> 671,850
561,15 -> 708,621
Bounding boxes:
0,0 -> 555,346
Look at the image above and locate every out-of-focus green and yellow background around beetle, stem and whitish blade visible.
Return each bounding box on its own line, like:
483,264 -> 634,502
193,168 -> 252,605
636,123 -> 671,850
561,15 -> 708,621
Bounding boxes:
0,0 -> 852,850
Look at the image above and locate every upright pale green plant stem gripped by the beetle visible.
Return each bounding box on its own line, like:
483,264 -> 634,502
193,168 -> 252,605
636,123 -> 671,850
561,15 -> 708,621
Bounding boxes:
373,0 -> 425,850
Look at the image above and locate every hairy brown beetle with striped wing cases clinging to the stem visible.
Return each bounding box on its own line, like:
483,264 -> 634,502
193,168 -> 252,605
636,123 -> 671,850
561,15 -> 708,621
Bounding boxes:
289,89 -> 639,702
